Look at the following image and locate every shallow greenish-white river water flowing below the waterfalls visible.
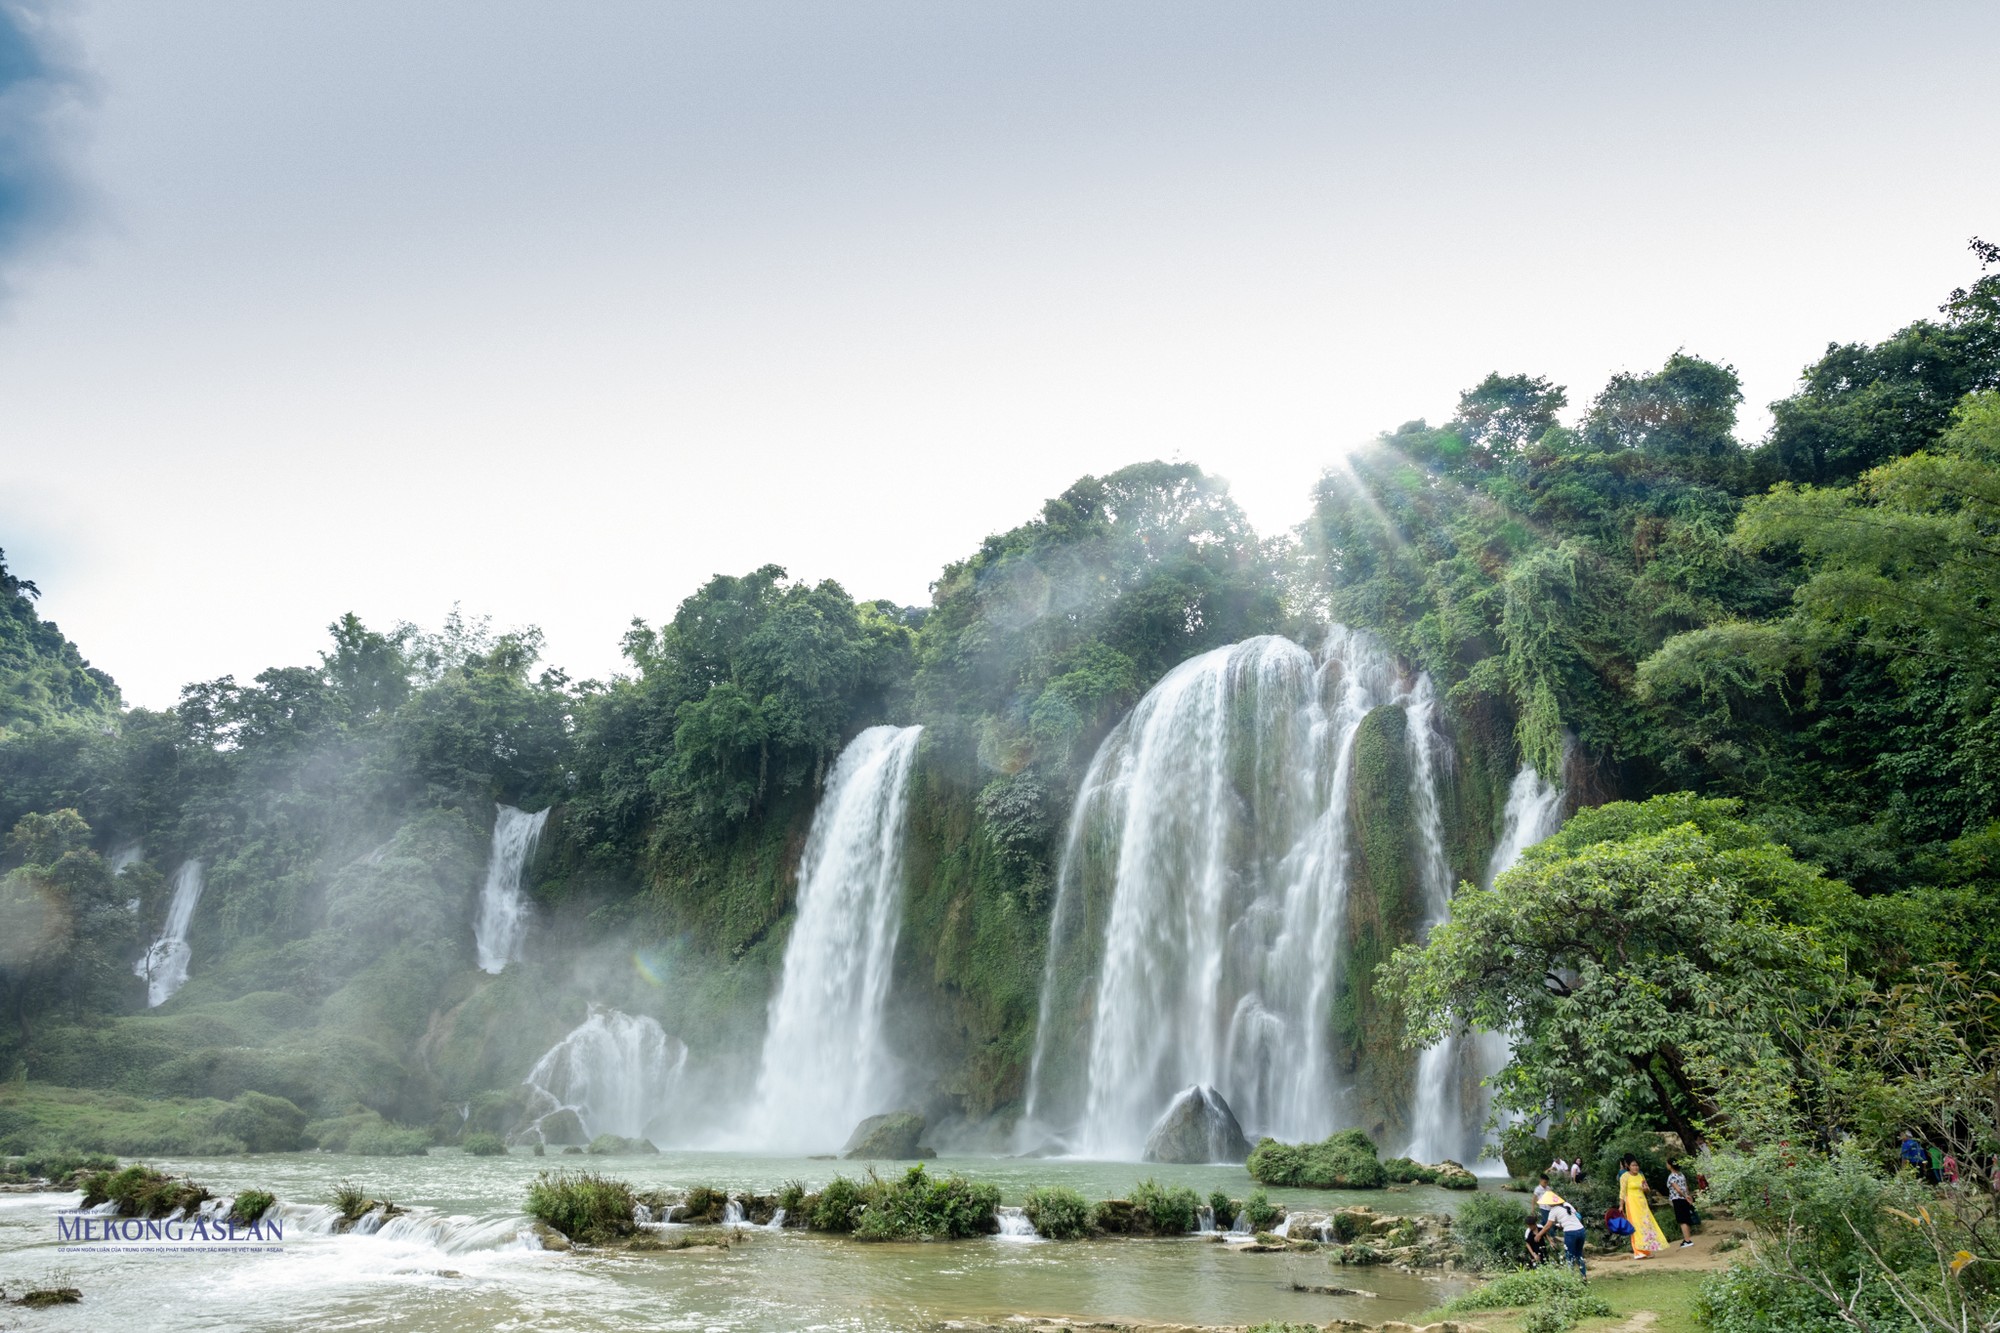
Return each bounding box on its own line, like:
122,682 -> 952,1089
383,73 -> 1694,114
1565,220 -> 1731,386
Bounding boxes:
0,1149 -> 1456,1333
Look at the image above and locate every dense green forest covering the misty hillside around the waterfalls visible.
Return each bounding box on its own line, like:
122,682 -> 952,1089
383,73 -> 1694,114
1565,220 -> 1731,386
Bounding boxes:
0,242 -> 2000,1305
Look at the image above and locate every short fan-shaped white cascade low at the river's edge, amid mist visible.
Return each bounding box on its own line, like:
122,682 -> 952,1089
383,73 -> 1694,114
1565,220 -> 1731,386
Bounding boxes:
520,1005 -> 688,1143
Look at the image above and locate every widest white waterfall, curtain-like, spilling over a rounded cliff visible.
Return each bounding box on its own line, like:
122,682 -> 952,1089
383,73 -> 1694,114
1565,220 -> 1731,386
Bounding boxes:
1026,626 -> 1416,1159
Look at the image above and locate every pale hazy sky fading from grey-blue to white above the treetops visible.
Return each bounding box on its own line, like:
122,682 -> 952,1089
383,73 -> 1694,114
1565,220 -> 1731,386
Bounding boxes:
0,0 -> 2000,705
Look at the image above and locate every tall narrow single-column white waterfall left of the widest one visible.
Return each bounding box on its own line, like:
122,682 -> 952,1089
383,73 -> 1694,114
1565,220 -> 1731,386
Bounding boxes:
750,727 -> 922,1151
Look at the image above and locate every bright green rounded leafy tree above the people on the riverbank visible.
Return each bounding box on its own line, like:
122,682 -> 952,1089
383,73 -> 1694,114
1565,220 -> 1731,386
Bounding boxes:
1382,795 -> 1852,1143
